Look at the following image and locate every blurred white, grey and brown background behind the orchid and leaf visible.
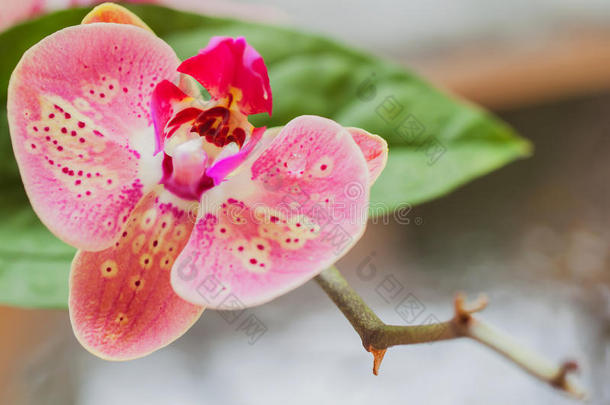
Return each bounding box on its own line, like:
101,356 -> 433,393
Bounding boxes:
0,0 -> 610,405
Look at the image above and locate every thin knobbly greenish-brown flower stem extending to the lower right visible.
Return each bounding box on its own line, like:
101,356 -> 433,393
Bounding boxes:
315,267 -> 586,399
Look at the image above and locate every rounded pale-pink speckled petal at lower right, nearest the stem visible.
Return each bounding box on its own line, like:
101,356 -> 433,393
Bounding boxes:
172,116 -> 369,309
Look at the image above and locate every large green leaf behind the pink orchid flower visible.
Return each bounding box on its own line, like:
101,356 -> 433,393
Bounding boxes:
0,5 -> 530,307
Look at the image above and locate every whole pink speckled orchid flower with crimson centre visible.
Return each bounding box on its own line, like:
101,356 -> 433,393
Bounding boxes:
8,5 -> 387,360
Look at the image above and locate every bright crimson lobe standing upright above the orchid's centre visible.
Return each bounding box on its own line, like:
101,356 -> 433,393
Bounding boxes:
178,37 -> 273,115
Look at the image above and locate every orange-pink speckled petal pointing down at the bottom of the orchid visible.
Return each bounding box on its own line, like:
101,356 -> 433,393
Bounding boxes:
69,187 -> 203,360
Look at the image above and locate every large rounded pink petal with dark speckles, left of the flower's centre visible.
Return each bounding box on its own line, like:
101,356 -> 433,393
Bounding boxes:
7,23 -> 178,250
